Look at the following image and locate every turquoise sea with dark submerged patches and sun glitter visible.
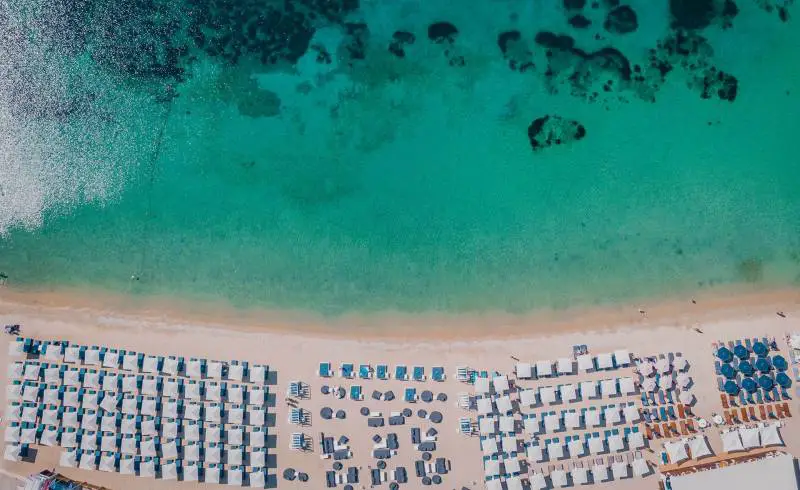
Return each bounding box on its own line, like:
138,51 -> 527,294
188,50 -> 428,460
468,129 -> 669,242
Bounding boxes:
0,0 -> 800,314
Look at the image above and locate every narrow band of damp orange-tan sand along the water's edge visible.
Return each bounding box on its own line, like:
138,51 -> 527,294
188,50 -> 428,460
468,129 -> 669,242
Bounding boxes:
0,286 -> 800,342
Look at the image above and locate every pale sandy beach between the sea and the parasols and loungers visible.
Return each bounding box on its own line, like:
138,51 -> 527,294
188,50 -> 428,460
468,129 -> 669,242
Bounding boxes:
0,290 -> 800,489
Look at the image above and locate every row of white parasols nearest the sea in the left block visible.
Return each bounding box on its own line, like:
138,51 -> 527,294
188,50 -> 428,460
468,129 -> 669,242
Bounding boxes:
9,337 -> 269,385
